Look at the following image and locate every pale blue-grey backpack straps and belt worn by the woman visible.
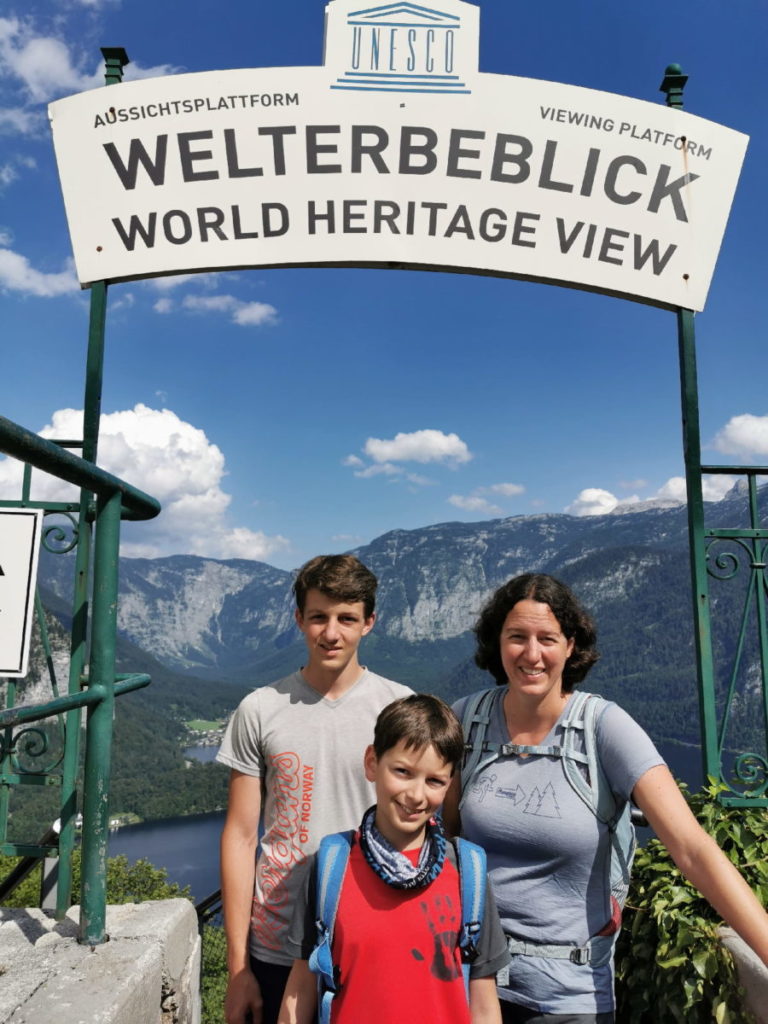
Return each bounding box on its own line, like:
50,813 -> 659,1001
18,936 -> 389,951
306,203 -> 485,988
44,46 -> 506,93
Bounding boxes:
459,686 -> 637,966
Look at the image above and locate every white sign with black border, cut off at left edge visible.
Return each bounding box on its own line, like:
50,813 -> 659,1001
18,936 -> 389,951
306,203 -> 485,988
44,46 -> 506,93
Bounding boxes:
0,509 -> 43,676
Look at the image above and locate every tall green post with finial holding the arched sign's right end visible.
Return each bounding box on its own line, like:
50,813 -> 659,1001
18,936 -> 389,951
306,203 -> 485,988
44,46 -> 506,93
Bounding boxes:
660,63 -> 720,778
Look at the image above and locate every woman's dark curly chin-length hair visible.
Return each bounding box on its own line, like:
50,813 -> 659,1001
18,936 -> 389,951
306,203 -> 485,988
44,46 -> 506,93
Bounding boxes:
474,572 -> 600,693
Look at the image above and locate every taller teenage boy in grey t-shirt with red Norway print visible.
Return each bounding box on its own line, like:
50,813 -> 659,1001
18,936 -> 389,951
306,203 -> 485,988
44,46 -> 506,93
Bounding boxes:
217,555 -> 411,1024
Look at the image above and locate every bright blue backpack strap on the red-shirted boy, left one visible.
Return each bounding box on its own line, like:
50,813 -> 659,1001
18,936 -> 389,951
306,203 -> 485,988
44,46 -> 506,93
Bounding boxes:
308,831 -> 354,1024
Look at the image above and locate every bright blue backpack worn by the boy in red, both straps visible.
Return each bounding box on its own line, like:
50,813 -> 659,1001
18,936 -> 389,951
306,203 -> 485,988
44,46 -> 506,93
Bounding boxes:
308,831 -> 486,1024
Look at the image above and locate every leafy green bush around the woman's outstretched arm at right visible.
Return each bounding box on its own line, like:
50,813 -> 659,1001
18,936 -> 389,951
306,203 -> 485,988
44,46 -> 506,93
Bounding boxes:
616,778 -> 768,1024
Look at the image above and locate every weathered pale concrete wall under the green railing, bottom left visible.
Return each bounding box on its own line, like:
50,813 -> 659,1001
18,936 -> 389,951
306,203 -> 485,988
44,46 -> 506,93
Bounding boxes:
0,899 -> 200,1024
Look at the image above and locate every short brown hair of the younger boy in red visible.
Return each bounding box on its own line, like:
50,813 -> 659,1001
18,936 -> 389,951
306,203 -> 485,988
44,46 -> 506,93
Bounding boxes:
374,693 -> 464,770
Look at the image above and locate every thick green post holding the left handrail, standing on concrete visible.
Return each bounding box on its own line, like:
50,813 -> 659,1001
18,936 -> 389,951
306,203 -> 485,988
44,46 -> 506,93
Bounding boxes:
78,492 -> 121,945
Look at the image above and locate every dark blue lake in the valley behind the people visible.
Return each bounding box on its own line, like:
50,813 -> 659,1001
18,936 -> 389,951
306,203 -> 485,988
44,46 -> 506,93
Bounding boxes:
109,743 -> 702,901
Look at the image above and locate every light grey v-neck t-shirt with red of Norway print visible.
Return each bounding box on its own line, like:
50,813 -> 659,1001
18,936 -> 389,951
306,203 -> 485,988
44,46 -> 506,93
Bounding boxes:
216,670 -> 412,965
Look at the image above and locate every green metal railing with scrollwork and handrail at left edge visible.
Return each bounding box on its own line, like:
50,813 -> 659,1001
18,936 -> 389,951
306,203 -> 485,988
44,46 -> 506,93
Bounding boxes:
0,417 -> 160,945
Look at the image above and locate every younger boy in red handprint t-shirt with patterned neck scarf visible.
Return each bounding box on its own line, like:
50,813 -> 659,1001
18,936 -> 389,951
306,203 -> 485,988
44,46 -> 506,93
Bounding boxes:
280,694 -> 509,1024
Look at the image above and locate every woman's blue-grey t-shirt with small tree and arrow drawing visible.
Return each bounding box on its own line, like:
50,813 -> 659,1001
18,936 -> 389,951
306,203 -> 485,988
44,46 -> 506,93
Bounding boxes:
454,687 -> 664,1014
